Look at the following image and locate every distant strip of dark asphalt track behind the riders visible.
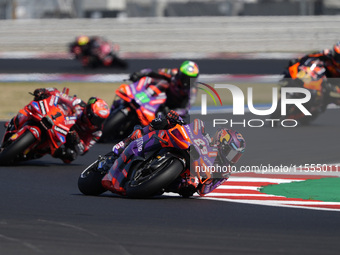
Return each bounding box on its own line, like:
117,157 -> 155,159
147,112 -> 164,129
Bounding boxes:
0,59 -> 288,74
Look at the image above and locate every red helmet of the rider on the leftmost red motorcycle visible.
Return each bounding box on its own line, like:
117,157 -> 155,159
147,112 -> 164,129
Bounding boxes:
84,97 -> 110,127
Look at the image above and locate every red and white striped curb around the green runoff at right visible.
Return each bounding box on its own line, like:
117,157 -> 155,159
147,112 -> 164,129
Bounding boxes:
201,173 -> 340,211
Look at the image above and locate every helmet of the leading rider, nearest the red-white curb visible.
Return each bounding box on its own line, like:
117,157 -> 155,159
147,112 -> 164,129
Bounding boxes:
213,128 -> 246,164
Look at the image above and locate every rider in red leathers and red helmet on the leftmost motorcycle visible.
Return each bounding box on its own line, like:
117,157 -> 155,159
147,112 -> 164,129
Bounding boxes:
33,88 -> 110,163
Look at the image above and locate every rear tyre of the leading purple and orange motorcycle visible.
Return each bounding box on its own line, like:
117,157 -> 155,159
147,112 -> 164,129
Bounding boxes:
78,160 -> 106,196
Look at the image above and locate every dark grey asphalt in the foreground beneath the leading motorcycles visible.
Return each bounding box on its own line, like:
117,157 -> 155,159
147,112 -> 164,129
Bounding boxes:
0,60 -> 340,255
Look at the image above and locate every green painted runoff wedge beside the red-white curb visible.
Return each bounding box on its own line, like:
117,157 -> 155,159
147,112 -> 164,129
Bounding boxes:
260,177 -> 340,202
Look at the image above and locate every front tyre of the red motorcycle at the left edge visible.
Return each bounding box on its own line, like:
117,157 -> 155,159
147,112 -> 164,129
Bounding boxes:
0,131 -> 36,165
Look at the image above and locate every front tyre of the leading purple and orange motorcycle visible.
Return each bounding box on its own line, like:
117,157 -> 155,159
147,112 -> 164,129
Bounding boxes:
125,157 -> 184,198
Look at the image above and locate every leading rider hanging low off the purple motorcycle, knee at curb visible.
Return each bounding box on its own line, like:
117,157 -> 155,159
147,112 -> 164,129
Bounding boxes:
112,110 -> 246,197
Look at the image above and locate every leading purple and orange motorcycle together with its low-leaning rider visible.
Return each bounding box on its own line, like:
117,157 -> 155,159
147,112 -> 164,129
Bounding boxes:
78,119 -> 245,198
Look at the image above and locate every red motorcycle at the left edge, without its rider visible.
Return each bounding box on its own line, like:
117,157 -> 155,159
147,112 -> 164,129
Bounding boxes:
0,89 -> 77,165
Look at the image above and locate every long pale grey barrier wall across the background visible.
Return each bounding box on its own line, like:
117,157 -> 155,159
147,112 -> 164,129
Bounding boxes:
0,16 -> 340,53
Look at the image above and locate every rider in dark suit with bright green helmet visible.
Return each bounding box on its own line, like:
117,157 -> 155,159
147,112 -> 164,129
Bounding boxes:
130,61 -> 199,116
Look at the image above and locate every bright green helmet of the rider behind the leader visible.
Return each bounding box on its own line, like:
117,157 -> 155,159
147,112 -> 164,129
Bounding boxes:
174,60 -> 199,90
